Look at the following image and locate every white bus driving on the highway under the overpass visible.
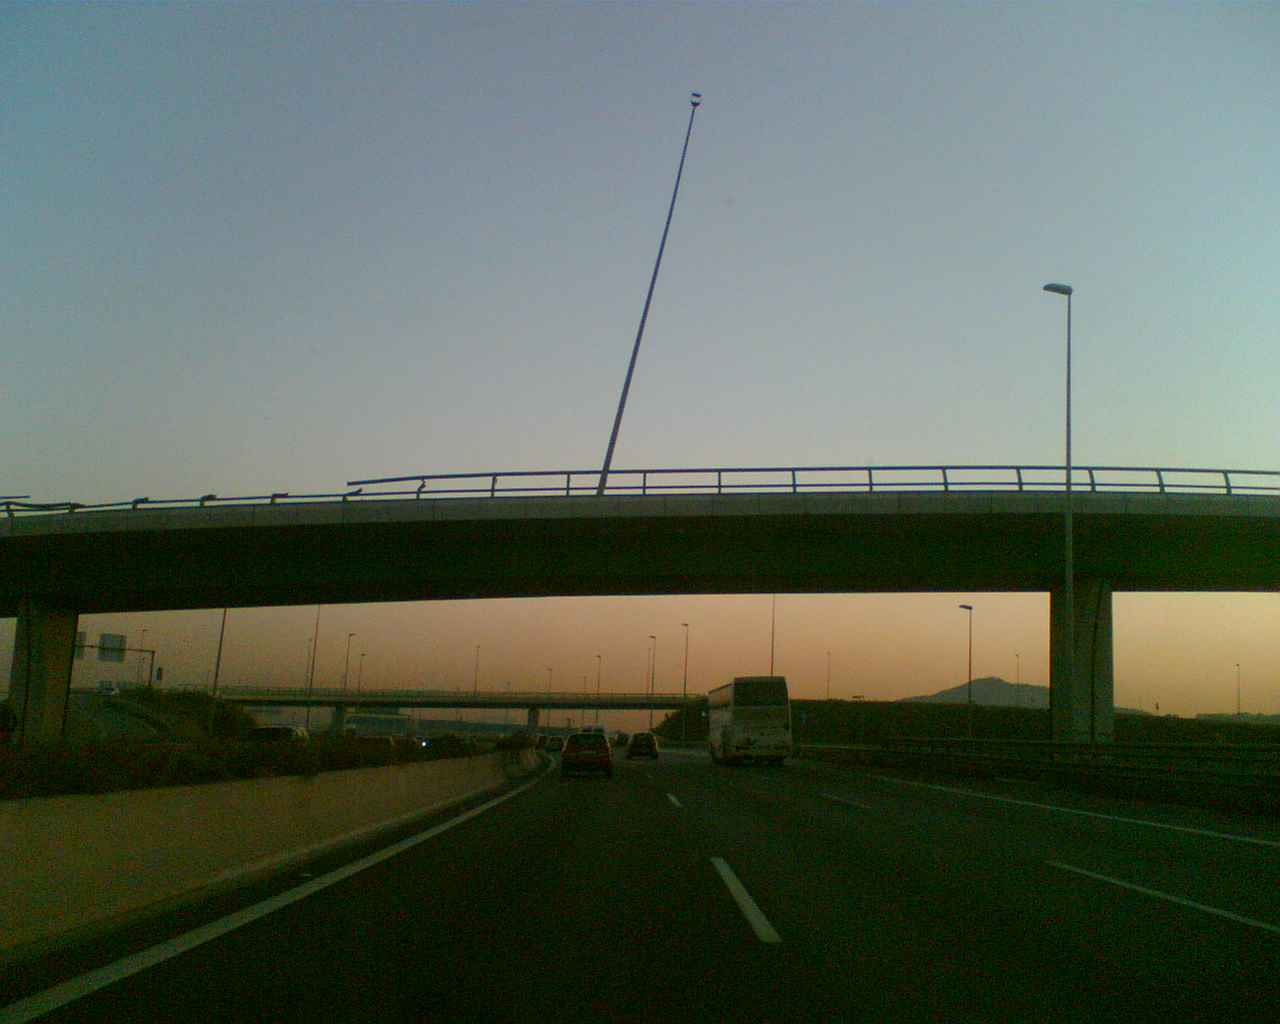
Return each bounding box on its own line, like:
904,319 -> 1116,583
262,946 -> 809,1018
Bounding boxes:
707,676 -> 791,764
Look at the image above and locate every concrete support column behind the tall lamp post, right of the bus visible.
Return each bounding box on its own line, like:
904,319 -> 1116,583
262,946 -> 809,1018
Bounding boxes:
1048,579 -> 1115,744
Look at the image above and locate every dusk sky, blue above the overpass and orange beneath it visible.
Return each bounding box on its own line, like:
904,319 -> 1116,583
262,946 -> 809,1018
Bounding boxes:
0,3 -> 1280,714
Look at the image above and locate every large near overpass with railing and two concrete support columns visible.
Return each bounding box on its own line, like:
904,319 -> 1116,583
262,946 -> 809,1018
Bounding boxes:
0,466 -> 1280,741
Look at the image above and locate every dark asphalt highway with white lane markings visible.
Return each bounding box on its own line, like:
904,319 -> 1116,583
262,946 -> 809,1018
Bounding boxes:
0,749 -> 1280,1024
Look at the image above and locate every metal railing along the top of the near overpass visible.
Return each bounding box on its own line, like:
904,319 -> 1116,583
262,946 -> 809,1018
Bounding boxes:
0,466 -> 1280,516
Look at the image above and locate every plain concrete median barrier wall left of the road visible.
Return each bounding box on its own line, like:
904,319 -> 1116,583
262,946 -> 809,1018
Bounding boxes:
0,751 -> 540,964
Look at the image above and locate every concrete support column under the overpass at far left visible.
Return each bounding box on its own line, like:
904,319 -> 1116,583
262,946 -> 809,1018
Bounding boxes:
9,598 -> 79,744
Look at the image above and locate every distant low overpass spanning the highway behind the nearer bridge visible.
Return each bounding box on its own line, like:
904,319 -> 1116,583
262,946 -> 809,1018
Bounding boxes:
218,686 -> 705,730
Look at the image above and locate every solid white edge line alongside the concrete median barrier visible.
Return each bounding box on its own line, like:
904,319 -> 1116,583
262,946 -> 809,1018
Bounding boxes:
0,778 -> 538,1024
